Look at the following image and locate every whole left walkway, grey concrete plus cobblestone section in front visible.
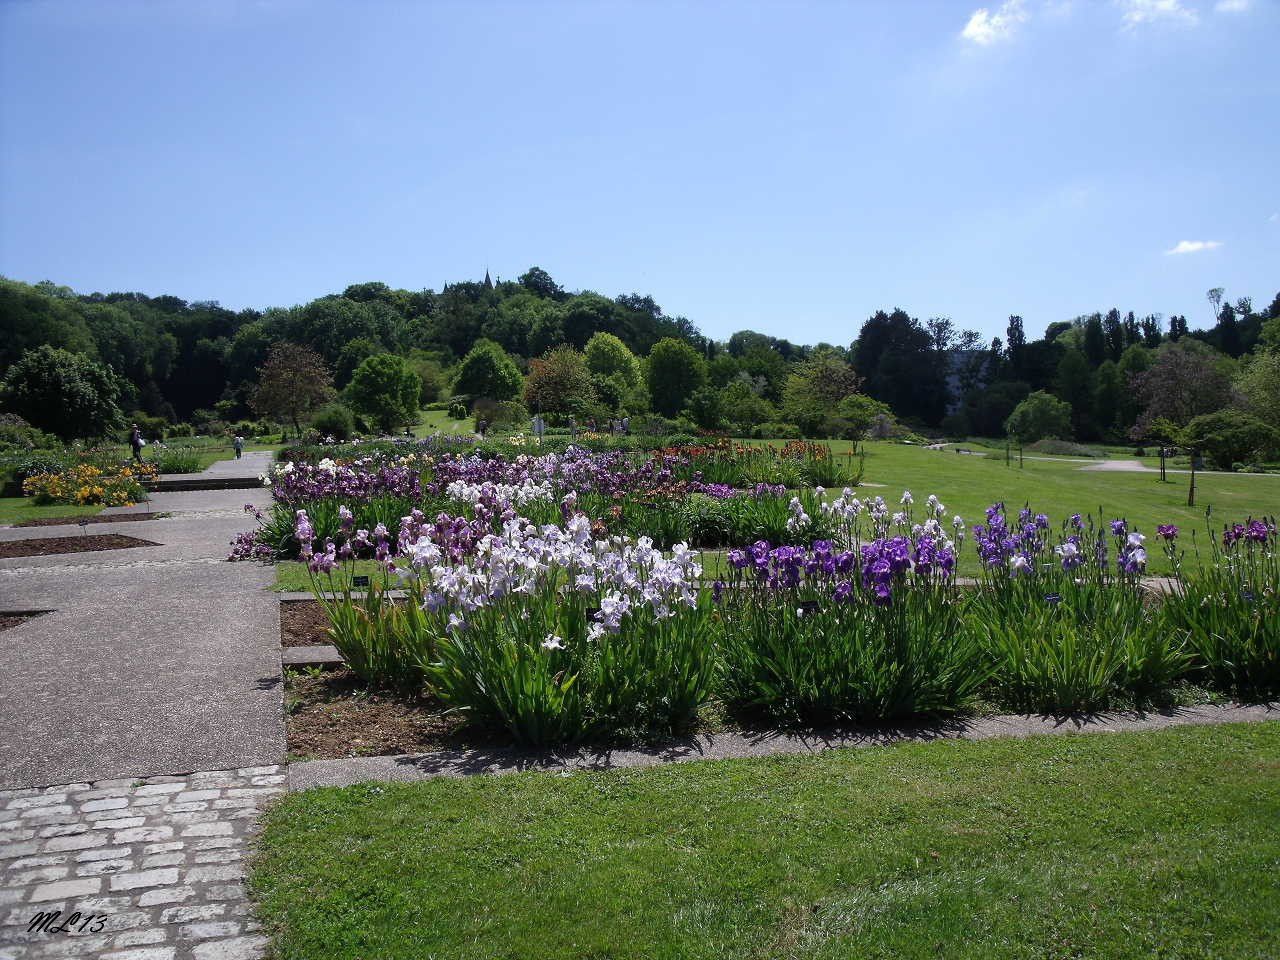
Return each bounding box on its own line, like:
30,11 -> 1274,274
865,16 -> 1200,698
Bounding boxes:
0,454 -> 284,960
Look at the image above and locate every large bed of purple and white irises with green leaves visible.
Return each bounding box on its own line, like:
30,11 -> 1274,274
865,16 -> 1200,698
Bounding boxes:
238,451 -> 1280,744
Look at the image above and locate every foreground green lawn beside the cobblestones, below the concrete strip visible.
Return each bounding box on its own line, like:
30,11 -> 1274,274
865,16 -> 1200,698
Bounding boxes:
252,723 -> 1280,960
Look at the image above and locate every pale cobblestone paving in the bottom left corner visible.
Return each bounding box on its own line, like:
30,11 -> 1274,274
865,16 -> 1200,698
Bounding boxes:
0,764 -> 285,960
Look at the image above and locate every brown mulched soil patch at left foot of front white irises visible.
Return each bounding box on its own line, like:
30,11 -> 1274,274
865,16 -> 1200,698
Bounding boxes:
284,668 -> 491,760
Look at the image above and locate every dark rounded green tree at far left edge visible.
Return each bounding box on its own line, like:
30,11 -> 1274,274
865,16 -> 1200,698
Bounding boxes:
0,343 -> 122,440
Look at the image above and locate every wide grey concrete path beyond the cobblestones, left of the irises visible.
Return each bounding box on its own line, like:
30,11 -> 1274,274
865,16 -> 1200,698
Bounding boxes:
0,489 -> 284,787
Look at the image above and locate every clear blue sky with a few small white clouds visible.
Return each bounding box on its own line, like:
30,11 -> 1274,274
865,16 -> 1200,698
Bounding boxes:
0,0 -> 1280,343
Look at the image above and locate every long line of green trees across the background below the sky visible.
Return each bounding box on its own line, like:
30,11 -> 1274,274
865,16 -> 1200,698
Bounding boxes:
0,266 -> 1280,455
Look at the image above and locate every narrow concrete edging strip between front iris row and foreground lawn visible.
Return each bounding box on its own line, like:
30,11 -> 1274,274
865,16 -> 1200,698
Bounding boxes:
288,704 -> 1280,790
